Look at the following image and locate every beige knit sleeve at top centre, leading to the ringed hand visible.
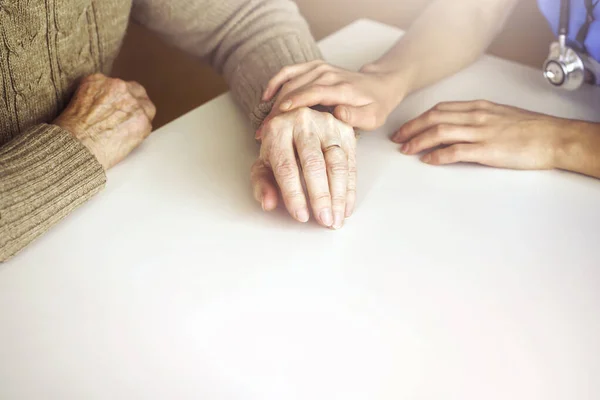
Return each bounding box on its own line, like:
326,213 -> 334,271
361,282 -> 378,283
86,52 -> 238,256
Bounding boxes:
132,0 -> 321,127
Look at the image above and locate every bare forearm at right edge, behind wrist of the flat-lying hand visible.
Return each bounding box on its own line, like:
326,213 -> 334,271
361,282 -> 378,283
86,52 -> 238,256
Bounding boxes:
555,121 -> 600,178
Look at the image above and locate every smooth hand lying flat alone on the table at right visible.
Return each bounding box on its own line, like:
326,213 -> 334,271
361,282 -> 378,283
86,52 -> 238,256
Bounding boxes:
392,100 -> 570,169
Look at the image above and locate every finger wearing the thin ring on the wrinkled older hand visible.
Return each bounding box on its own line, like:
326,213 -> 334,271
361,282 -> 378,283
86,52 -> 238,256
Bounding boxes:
323,145 -> 348,229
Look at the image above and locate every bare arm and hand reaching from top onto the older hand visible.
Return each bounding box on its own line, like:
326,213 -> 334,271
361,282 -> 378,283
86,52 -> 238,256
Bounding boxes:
263,0 -> 518,130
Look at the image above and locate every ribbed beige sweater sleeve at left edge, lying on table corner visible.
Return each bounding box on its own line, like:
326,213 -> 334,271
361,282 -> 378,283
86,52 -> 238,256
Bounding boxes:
0,124 -> 106,262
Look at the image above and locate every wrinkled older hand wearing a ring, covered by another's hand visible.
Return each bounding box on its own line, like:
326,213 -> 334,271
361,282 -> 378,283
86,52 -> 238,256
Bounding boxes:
252,108 -> 356,229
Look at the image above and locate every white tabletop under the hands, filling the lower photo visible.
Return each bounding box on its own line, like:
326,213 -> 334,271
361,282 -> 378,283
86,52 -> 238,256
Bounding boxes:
0,21 -> 600,400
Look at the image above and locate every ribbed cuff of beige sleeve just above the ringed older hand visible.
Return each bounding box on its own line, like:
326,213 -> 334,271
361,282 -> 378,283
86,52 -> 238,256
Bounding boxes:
225,33 -> 322,129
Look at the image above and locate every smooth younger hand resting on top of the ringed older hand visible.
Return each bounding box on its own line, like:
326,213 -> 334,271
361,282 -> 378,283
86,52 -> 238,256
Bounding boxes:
263,61 -> 403,130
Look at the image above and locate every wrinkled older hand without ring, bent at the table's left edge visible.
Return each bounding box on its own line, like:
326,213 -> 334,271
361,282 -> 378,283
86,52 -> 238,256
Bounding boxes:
54,74 -> 156,170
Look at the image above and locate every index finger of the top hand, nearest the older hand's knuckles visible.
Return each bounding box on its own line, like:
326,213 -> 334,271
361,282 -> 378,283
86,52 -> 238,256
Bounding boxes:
281,83 -> 367,111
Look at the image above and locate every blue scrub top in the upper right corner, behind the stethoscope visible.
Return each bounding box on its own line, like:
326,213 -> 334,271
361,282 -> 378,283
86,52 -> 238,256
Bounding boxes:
538,0 -> 600,62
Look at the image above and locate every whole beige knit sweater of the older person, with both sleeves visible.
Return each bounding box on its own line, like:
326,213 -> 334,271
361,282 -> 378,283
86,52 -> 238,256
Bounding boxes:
0,0 -> 320,261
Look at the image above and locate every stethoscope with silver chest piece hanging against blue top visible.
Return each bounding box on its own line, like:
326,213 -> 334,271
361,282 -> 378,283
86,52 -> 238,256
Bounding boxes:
544,0 -> 600,90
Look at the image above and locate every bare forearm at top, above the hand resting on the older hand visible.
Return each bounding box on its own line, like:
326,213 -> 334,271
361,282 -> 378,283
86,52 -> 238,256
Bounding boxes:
363,0 -> 516,102
